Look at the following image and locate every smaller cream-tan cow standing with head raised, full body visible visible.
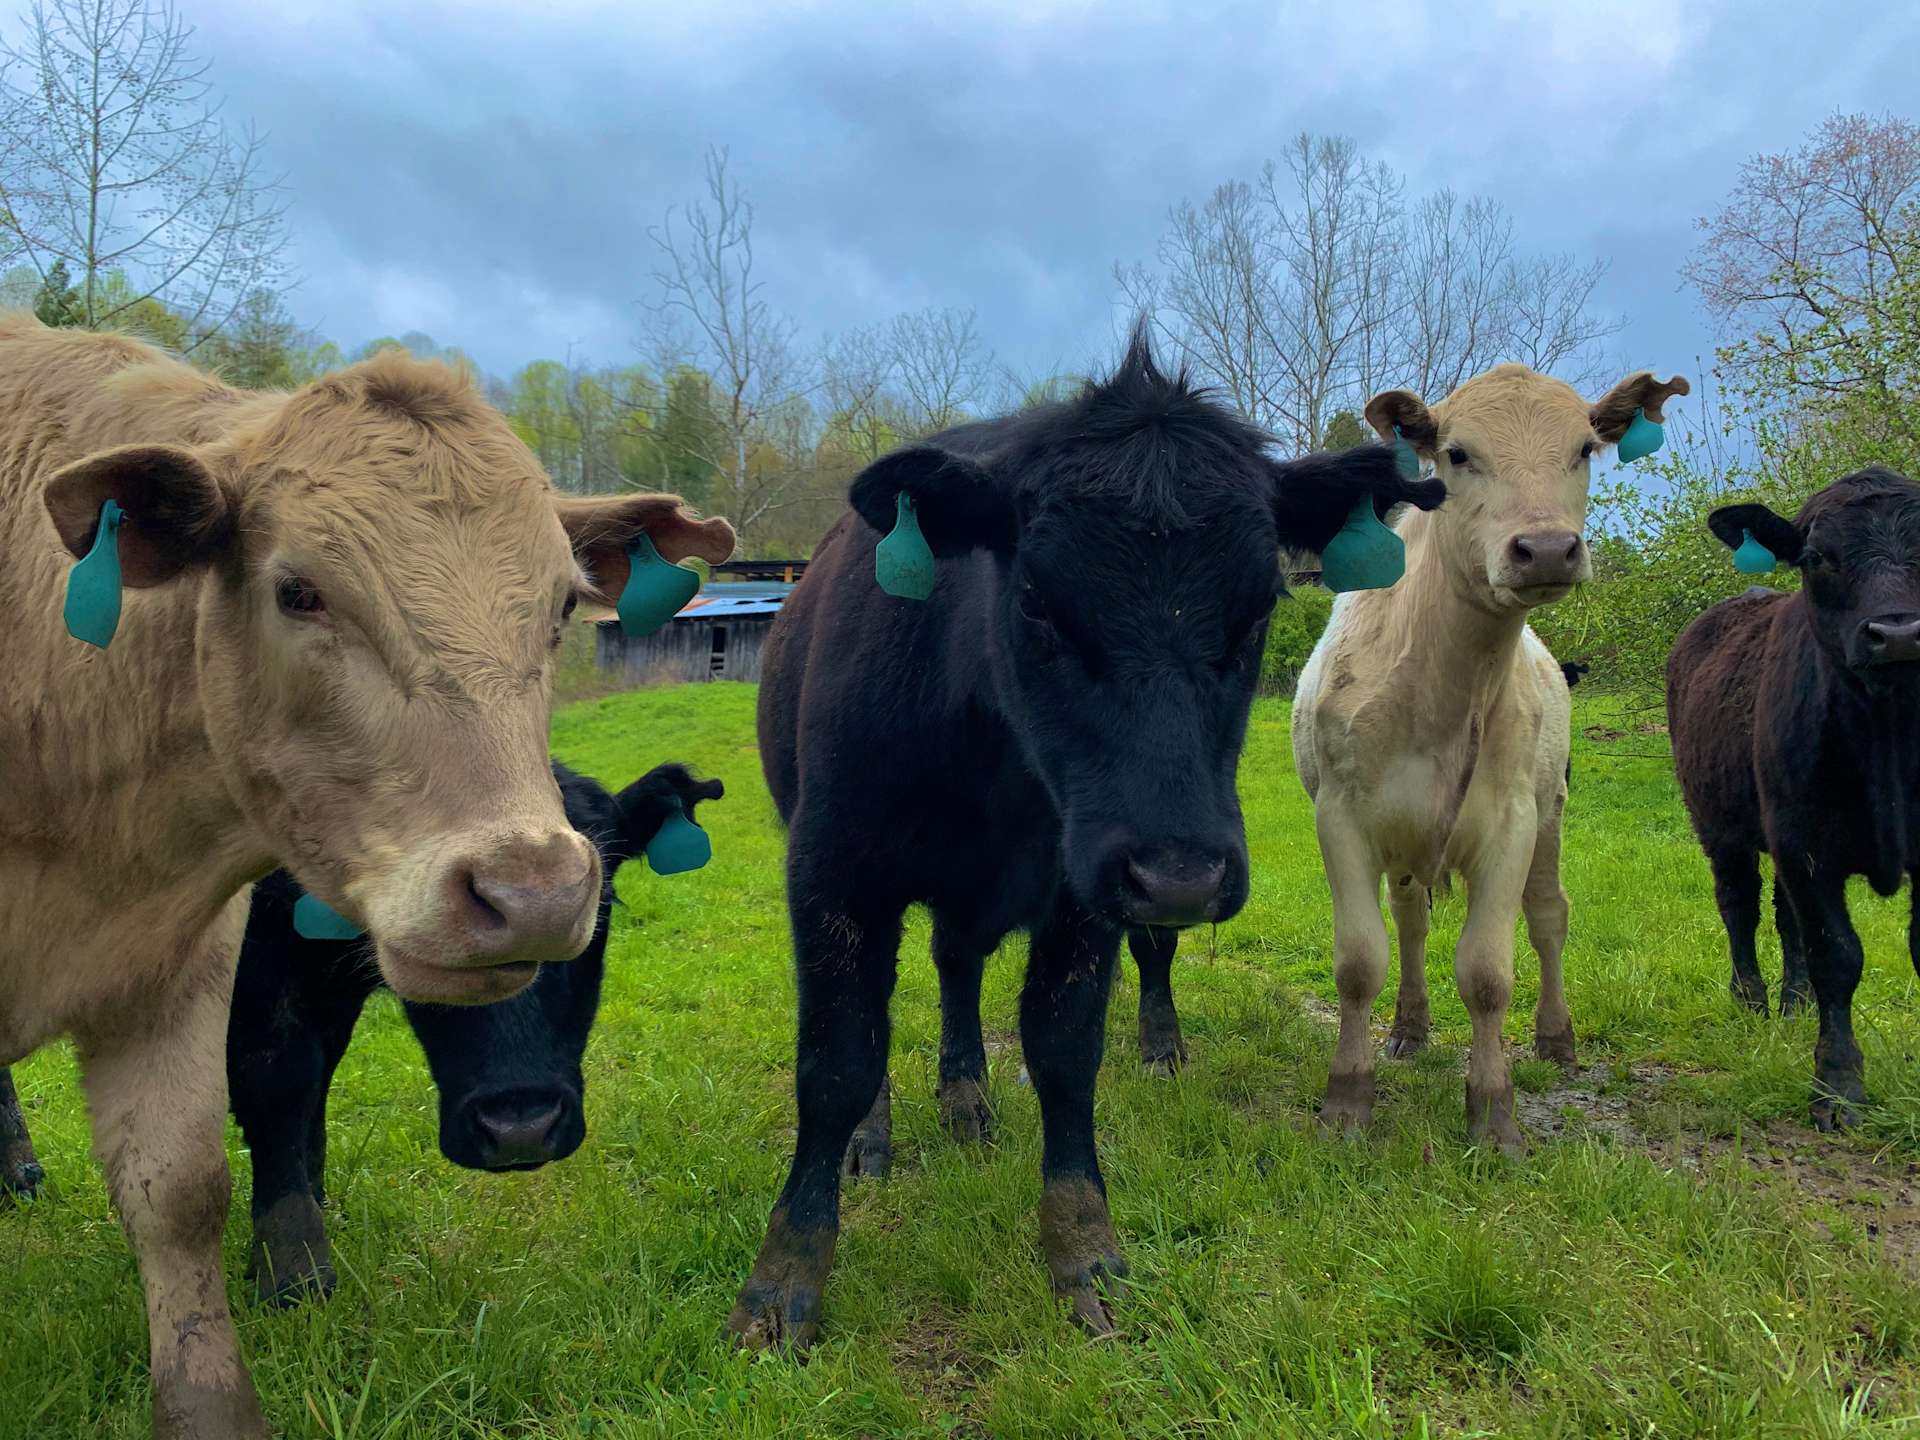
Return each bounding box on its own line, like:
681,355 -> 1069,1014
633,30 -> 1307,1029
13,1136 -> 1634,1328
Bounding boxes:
1294,365 -> 1688,1152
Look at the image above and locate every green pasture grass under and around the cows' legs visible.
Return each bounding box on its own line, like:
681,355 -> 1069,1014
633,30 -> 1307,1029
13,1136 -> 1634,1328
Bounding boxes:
0,684 -> 1920,1440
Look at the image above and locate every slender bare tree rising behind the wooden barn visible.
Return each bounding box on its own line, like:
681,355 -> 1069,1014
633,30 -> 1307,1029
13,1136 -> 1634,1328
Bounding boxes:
649,148 -> 806,534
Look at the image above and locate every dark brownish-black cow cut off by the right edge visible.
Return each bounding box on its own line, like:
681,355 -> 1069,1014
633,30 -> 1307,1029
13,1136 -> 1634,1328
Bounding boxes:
1667,467 -> 1920,1129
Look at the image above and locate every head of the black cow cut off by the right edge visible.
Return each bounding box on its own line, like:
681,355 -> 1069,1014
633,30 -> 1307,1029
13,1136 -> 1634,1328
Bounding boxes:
1707,465 -> 1920,684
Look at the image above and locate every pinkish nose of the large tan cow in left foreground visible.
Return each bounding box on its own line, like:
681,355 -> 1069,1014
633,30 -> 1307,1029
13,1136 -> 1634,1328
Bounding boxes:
445,829 -> 599,966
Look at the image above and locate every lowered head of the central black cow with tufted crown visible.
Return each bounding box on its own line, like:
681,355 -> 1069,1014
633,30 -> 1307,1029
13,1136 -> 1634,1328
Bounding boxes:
851,332 -> 1446,925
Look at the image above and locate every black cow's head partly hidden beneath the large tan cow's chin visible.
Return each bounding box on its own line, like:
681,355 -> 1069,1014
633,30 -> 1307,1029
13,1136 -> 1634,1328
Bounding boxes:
407,764 -> 724,1171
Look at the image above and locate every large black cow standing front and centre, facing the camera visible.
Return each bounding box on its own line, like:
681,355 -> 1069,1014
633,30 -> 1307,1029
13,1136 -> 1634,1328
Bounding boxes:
728,334 -> 1446,1348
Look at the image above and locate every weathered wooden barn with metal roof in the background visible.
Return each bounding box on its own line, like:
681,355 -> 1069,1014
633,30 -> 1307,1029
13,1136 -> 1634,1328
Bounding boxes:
593,561 -> 806,685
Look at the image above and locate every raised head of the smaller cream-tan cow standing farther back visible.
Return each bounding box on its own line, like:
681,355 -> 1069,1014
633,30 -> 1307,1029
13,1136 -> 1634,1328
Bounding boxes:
1367,365 -> 1688,609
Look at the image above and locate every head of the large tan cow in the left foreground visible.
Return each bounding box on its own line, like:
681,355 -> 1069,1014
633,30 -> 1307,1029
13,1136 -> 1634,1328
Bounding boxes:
46,357 -> 733,1002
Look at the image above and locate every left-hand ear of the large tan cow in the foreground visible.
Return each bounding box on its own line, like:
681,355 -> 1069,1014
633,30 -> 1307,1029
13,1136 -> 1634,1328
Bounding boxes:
46,445 -> 234,589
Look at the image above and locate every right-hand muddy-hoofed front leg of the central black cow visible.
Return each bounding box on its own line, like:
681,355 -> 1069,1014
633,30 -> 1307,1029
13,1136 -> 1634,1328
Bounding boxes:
1020,889 -> 1127,1334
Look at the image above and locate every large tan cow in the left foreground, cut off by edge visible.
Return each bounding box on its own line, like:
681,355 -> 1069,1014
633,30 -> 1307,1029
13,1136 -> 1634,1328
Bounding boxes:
0,317 -> 733,1440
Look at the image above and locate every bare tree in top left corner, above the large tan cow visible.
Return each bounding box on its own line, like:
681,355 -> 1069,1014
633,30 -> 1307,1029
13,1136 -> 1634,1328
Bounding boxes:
0,0 -> 286,348
